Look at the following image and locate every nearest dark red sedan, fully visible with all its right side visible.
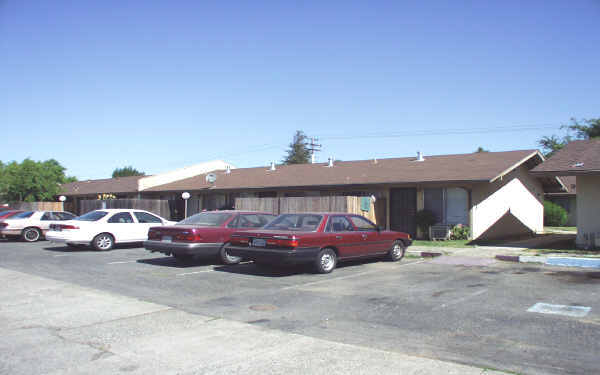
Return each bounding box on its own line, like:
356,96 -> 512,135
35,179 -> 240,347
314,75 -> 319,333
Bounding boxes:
227,213 -> 412,273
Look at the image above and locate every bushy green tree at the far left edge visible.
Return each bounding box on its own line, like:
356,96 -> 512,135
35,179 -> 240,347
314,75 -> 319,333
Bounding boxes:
0,159 -> 74,202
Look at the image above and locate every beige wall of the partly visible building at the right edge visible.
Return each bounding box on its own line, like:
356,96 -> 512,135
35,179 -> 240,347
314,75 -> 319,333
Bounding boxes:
576,176 -> 600,248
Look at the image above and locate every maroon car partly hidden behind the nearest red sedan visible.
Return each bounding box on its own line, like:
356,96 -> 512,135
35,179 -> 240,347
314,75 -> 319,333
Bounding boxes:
144,211 -> 275,264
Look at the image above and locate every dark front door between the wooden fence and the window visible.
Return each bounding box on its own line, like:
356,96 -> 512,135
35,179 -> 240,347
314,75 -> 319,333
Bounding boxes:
390,188 -> 417,237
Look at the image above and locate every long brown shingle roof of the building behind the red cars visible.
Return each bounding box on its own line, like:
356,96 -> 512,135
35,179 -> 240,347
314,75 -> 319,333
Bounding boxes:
144,150 -> 541,191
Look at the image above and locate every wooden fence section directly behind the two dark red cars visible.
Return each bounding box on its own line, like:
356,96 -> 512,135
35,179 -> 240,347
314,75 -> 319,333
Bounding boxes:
235,196 -> 387,227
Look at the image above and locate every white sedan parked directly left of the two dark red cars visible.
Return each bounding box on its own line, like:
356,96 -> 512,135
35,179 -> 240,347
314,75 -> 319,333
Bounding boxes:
46,209 -> 175,250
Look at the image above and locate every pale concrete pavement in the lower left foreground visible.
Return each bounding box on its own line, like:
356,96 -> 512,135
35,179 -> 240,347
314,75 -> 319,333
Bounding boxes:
0,268 -> 502,375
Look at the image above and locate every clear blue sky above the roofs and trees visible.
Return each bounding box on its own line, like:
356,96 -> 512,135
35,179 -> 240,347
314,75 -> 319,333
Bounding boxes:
0,0 -> 600,179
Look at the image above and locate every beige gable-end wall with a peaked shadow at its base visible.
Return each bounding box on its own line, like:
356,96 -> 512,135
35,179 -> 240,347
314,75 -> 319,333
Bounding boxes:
470,166 -> 544,239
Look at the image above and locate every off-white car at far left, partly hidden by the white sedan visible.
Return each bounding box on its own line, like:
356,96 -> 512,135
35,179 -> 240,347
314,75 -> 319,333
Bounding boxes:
0,211 -> 75,242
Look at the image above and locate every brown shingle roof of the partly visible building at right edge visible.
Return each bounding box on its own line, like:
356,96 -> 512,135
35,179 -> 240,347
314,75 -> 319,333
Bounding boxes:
532,139 -> 600,176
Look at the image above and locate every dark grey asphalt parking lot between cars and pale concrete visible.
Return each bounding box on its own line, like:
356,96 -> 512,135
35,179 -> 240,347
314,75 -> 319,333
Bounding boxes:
0,241 -> 600,374
